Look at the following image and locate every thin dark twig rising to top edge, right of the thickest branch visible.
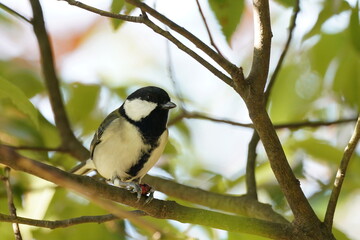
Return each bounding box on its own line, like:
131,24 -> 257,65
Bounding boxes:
265,0 -> 300,101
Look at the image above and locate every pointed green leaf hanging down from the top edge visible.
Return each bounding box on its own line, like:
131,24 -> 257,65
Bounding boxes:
209,0 -> 245,42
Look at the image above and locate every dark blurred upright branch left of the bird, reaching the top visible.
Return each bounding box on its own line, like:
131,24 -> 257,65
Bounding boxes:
30,0 -> 89,160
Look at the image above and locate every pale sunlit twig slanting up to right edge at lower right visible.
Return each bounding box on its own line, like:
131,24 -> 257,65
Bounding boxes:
324,117 -> 360,229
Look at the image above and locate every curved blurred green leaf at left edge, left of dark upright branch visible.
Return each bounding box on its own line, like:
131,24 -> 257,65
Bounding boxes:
0,77 -> 39,128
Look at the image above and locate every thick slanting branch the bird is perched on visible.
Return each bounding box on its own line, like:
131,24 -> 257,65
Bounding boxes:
0,145 -> 293,239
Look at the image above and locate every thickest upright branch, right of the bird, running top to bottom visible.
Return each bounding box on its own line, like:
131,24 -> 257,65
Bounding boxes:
229,0 -> 334,236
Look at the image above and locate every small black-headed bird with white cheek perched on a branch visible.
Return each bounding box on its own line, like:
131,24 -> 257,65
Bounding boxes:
71,86 -> 176,201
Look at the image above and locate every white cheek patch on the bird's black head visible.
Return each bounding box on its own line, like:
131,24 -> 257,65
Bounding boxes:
124,99 -> 157,122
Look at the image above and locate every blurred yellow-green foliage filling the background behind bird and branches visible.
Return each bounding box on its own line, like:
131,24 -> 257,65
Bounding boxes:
0,0 -> 360,240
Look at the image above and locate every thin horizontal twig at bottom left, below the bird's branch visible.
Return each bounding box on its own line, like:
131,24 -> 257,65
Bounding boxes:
0,211 -> 146,229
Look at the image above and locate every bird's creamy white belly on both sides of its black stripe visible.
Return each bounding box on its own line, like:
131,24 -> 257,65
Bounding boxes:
93,119 -> 168,181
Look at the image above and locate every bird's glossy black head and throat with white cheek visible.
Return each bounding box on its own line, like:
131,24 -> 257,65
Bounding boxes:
120,86 -> 176,138
